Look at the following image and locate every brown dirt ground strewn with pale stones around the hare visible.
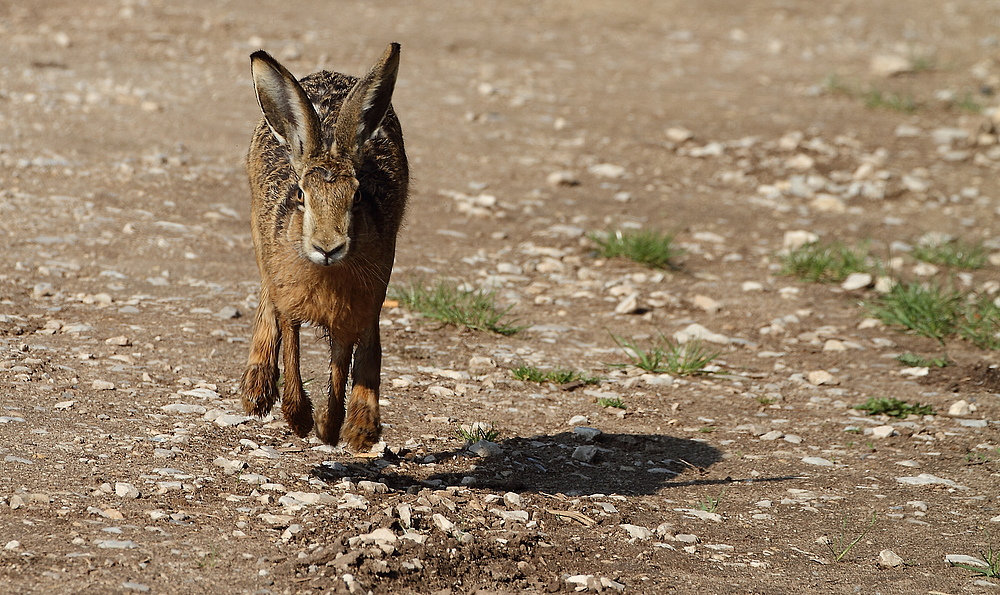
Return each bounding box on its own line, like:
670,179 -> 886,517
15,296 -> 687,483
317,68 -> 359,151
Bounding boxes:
0,0 -> 1000,594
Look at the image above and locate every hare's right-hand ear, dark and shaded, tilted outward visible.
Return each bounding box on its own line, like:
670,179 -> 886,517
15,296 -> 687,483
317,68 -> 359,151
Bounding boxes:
334,43 -> 399,160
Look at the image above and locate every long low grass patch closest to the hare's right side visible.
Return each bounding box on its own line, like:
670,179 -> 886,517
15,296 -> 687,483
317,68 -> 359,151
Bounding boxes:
390,280 -> 527,336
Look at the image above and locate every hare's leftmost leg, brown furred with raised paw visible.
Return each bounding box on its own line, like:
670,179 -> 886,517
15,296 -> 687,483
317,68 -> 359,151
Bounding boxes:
240,286 -> 281,417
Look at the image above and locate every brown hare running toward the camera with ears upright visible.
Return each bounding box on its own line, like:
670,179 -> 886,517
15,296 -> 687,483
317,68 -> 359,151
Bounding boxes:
240,43 -> 409,450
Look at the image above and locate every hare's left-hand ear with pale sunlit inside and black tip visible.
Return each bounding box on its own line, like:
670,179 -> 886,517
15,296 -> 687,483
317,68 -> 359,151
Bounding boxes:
250,50 -> 322,169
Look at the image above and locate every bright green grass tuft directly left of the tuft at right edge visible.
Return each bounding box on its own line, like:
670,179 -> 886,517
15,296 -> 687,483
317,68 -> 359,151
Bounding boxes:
869,283 -> 962,343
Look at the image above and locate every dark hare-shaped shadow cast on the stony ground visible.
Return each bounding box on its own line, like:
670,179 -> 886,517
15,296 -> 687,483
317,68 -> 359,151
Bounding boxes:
313,432 -> 793,496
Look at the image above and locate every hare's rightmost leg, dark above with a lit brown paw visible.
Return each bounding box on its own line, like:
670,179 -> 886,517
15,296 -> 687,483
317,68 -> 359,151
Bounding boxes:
343,319 -> 382,451
